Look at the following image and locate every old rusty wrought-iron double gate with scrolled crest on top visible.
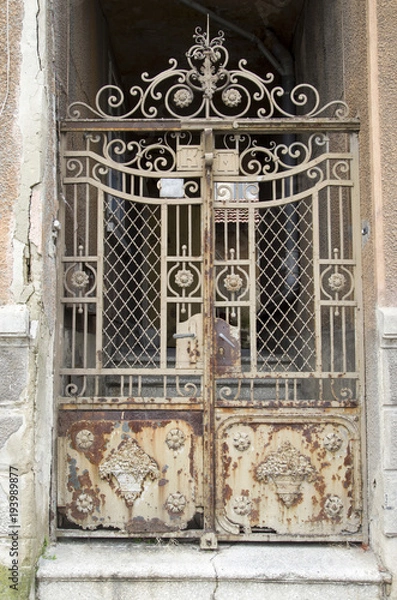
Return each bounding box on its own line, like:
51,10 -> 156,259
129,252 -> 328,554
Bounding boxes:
57,25 -> 363,547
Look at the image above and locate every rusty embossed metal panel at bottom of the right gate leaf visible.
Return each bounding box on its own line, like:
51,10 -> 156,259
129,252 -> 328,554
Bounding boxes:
217,415 -> 362,539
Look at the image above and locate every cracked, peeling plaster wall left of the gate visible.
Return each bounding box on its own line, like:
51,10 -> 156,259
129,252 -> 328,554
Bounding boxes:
0,0 -> 57,599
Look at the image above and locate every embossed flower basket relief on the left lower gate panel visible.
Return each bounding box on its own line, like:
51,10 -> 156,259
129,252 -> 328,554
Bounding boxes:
99,438 -> 160,506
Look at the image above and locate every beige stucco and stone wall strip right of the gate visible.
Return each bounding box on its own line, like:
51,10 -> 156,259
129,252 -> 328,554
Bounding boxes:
368,0 -> 397,598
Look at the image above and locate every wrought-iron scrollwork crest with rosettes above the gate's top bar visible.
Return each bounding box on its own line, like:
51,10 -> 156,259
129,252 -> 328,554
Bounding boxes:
67,27 -> 349,121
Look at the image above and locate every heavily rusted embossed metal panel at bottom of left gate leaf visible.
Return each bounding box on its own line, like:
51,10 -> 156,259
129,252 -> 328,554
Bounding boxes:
58,411 -> 203,534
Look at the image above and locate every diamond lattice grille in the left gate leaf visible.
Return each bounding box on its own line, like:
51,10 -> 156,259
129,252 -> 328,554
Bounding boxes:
103,198 -> 161,367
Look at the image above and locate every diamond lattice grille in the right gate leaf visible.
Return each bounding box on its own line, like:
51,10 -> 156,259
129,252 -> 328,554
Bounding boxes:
257,202 -> 315,371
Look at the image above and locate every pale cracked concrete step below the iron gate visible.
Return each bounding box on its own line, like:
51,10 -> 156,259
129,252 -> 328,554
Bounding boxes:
36,540 -> 390,600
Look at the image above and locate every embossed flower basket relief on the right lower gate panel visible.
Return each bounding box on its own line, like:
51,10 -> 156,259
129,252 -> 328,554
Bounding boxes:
255,442 -> 317,507
